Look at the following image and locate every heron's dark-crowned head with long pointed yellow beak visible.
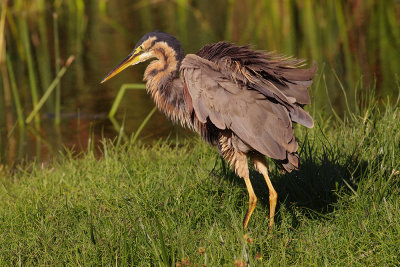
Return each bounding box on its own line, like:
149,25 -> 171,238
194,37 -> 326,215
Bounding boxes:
101,31 -> 184,83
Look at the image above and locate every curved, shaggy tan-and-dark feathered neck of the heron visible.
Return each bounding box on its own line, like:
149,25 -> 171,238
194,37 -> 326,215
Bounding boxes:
144,45 -> 186,122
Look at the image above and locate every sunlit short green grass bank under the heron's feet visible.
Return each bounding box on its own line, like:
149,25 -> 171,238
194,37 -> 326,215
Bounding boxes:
0,98 -> 400,266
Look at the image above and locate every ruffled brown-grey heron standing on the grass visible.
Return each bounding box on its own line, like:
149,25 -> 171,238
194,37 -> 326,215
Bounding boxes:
101,31 -> 317,230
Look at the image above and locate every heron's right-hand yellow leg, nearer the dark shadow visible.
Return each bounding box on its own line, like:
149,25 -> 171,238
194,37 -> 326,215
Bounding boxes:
251,155 -> 278,230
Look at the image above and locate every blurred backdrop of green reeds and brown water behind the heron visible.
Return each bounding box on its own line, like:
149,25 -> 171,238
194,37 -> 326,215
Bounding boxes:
0,0 -> 400,164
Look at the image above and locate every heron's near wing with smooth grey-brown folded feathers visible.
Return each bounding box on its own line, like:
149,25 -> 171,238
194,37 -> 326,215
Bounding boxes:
181,55 -> 298,160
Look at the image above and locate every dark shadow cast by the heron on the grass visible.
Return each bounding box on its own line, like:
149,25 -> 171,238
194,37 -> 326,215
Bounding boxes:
209,135 -> 367,228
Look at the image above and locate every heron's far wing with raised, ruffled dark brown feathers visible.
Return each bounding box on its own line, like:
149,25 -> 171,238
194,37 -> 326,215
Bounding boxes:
197,42 -> 317,128
